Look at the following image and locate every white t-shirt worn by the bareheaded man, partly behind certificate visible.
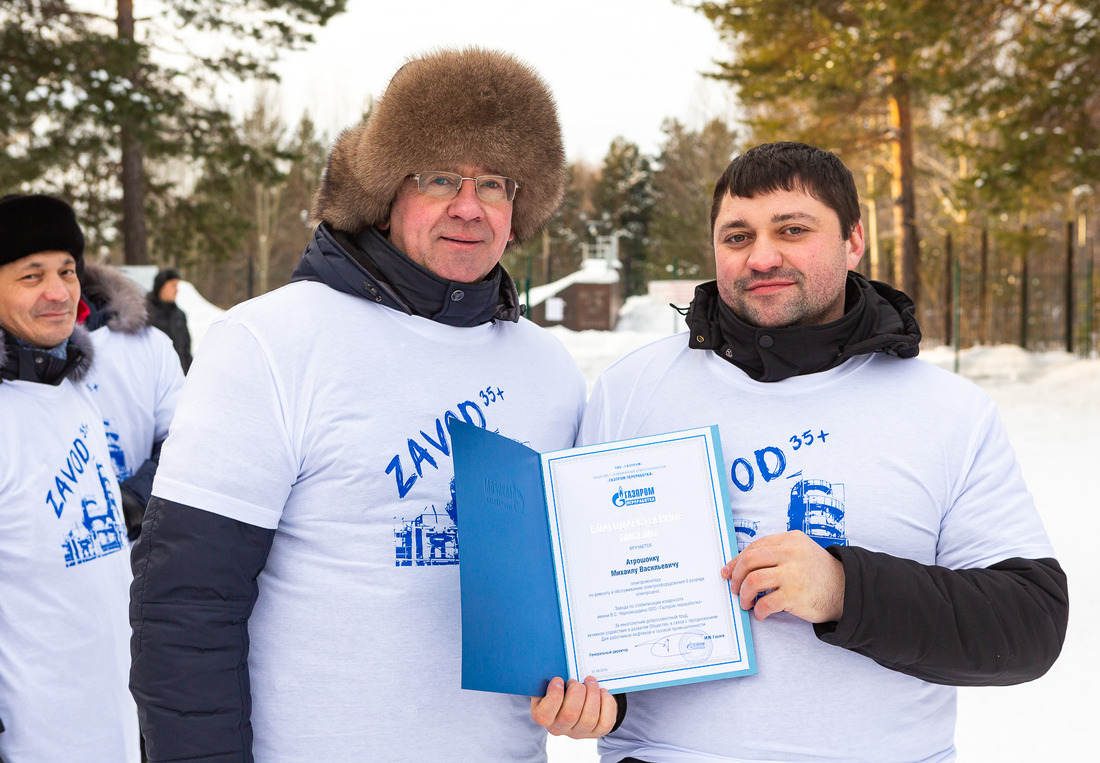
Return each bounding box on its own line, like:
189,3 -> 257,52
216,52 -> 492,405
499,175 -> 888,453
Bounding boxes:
580,334 -> 1054,763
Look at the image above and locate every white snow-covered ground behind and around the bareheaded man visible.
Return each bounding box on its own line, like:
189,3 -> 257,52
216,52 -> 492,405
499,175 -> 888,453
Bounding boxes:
548,314 -> 1100,763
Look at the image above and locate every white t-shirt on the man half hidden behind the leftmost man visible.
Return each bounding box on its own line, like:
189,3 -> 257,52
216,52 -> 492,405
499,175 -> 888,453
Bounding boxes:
83,325 -> 184,482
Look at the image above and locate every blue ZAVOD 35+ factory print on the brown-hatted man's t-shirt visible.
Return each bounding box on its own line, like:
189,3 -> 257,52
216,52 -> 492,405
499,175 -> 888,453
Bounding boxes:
385,386 -> 505,567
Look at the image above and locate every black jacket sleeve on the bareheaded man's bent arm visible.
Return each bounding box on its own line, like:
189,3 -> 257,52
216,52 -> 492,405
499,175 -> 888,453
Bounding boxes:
814,545 -> 1069,686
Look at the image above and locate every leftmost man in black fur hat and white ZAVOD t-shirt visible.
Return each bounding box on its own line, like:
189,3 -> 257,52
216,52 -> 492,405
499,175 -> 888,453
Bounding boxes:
0,196 -> 140,763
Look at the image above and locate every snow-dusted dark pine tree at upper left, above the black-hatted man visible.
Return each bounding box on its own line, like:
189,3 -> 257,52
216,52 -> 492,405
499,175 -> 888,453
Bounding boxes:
0,0 -> 347,264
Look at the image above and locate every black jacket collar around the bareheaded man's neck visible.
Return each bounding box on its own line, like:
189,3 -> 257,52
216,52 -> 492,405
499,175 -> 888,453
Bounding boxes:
688,272 -> 921,382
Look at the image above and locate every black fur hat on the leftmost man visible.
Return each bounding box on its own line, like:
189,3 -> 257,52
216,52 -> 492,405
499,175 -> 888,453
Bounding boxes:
0,193 -> 84,270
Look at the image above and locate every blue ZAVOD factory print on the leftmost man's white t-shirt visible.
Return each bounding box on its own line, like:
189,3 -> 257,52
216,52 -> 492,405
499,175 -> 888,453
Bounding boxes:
45,425 -> 125,567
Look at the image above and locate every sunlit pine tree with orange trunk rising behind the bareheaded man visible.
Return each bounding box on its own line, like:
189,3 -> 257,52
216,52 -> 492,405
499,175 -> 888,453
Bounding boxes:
696,0 -> 1015,299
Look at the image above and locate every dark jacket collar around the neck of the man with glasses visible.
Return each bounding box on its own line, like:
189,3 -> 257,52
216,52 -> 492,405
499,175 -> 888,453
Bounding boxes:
290,224 -> 523,327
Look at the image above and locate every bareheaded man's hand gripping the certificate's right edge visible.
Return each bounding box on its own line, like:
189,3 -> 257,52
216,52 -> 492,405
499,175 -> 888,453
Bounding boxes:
722,530 -> 844,622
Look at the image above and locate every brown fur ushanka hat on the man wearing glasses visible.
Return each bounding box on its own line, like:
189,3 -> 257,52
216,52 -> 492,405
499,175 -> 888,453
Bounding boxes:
310,48 -> 565,243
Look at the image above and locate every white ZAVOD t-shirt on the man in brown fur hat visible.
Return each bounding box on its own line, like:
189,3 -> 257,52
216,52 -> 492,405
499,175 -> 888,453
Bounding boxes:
153,283 -> 585,763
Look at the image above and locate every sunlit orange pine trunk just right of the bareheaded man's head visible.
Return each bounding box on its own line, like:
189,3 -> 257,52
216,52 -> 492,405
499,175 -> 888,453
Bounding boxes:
890,65 -> 921,306
